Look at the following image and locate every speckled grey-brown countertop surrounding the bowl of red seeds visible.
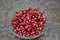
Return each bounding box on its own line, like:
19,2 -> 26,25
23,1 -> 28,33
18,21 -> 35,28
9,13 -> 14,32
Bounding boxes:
0,0 -> 60,40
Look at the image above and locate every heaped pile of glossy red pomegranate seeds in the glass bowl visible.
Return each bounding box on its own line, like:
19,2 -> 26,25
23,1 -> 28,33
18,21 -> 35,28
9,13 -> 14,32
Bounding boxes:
11,8 -> 46,37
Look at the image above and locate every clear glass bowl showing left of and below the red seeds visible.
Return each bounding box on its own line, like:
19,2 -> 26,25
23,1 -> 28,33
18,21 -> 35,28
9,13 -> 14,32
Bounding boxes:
7,8 -> 45,39
